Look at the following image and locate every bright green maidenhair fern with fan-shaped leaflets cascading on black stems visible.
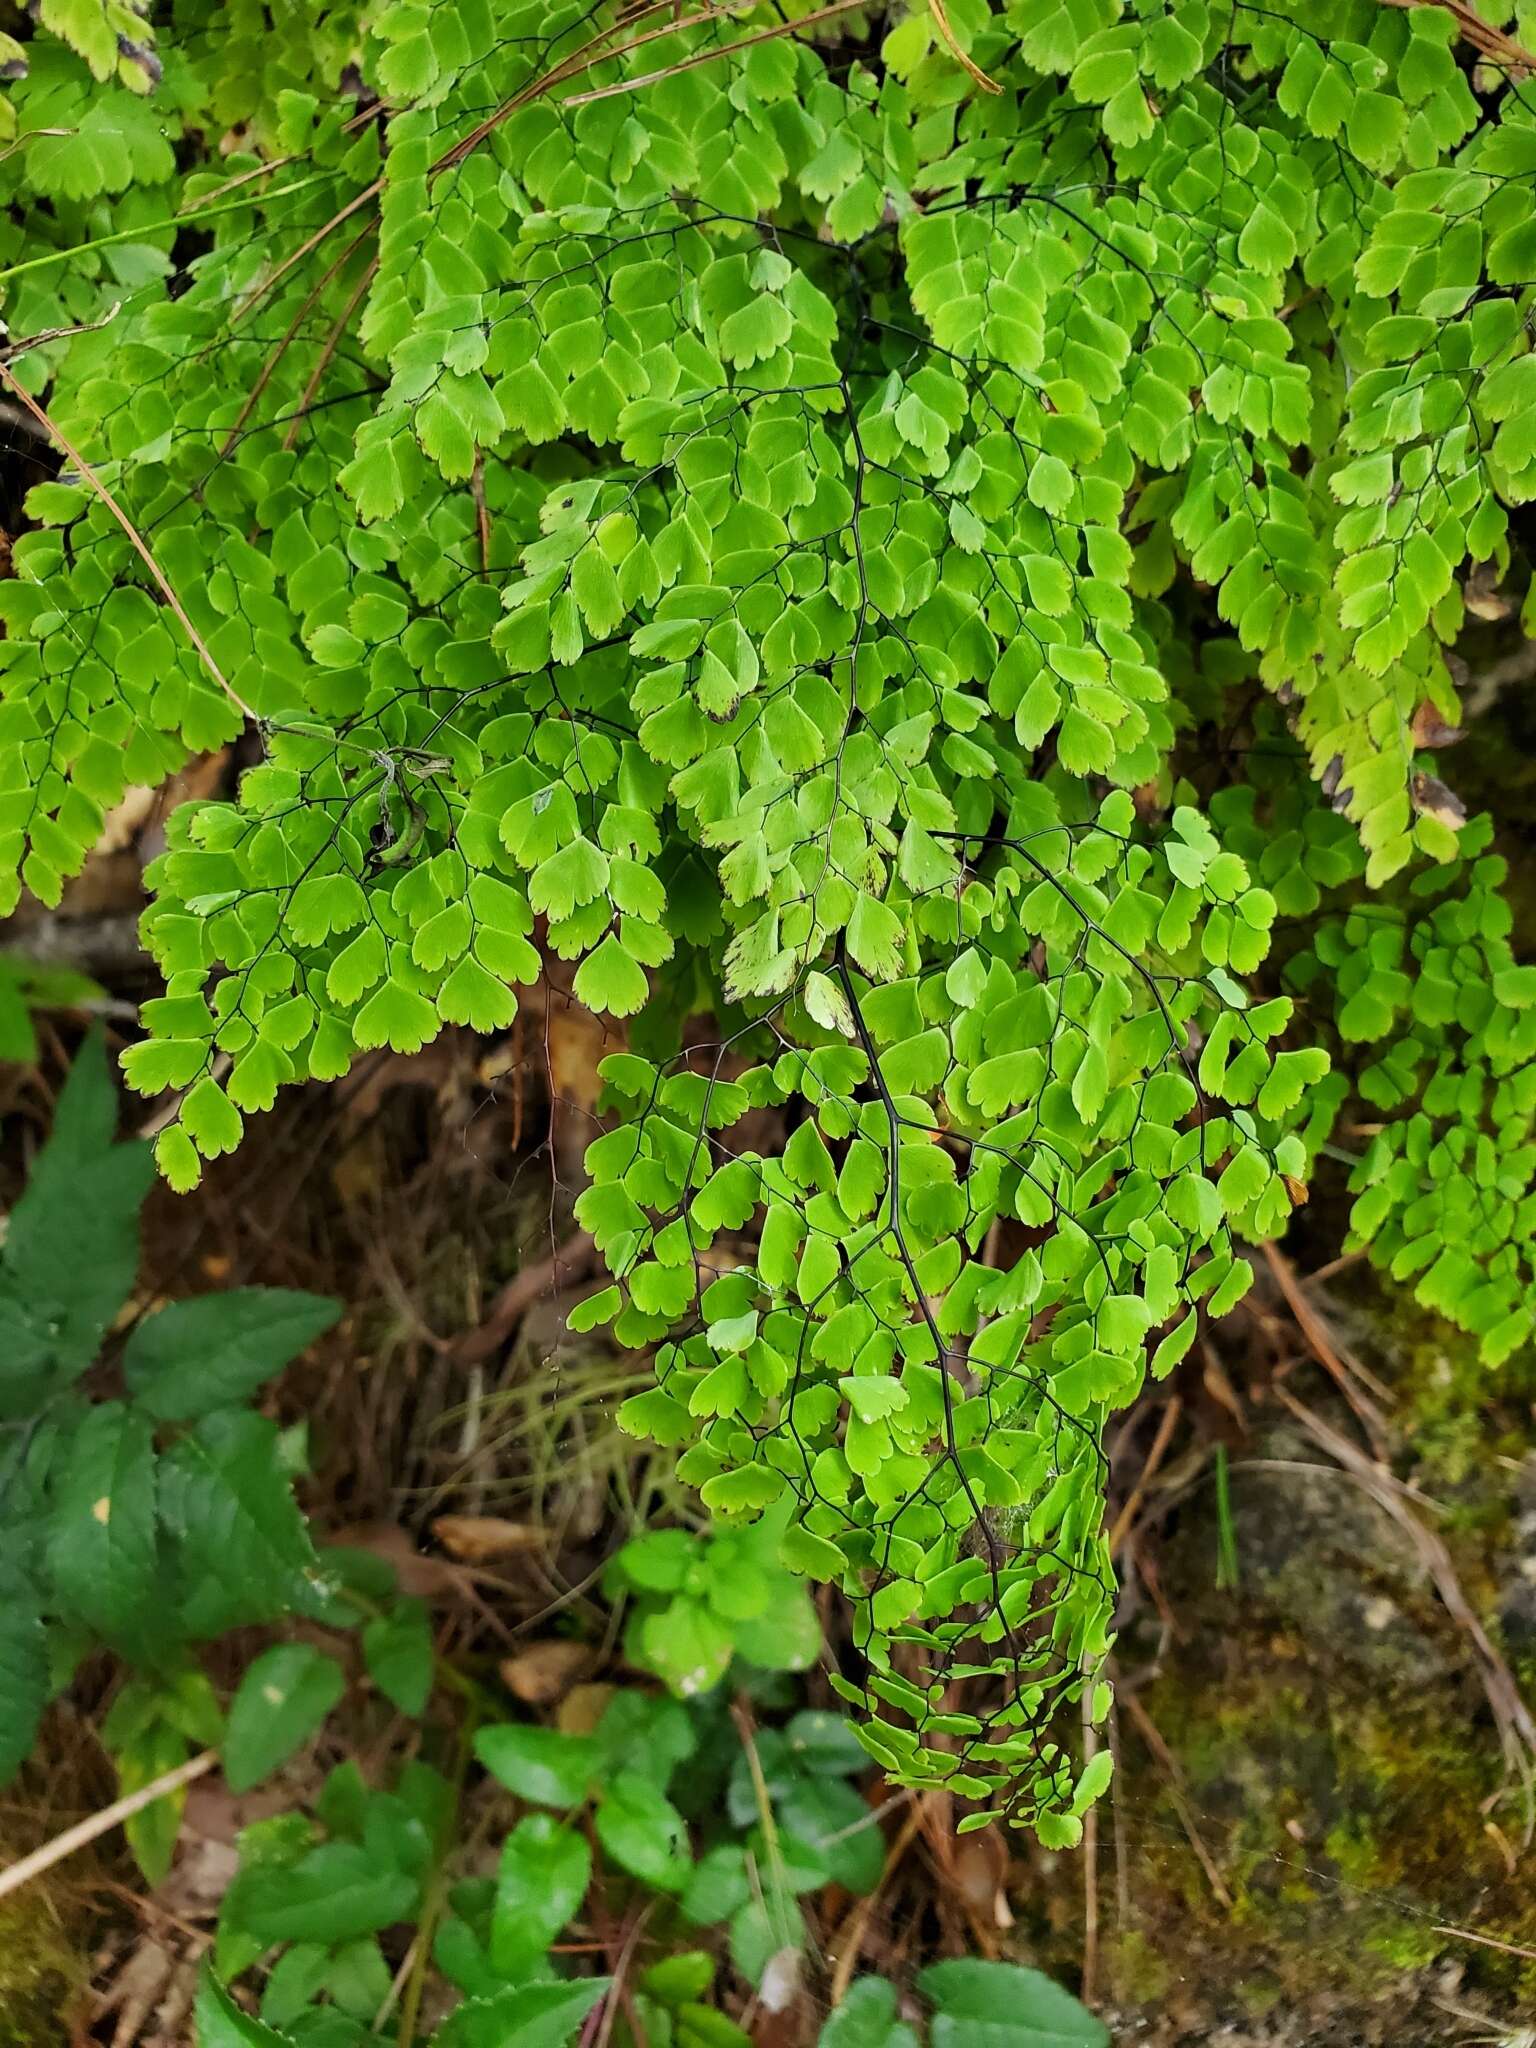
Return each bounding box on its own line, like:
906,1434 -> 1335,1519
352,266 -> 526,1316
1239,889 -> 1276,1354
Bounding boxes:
0,0 -> 1536,1843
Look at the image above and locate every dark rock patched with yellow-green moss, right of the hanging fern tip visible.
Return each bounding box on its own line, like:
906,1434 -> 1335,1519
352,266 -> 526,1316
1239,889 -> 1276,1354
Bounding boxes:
1020,1268 -> 1536,2048
